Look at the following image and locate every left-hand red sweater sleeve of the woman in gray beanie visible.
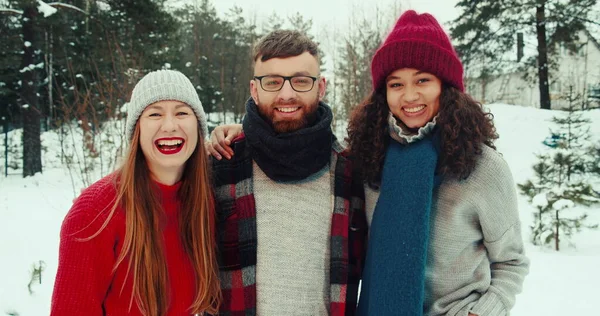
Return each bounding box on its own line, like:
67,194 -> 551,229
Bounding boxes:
51,186 -> 117,316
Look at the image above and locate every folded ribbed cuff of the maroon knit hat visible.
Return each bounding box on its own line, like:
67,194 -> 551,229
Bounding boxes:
371,38 -> 464,91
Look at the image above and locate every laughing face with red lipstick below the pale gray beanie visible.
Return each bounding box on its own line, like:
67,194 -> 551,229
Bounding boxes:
138,101 -> 198,183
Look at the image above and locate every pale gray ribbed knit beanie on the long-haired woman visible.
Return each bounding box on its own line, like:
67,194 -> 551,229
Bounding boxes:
126,70 -> 208,140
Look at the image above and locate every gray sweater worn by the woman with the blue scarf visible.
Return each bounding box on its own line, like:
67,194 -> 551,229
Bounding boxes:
366,117 -> 529,316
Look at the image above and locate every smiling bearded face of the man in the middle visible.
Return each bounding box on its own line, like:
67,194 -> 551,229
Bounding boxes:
250,52 -> 326,133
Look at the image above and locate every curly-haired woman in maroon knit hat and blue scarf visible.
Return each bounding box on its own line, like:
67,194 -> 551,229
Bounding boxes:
348,11 -> 529,316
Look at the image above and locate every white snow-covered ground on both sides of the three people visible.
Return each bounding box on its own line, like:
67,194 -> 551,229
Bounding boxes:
0,104 -> 600,316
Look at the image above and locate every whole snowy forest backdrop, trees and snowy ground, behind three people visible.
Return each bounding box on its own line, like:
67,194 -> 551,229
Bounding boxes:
0,0 -> 600,316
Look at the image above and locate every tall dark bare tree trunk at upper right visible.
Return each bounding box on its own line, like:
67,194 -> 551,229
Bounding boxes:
535,0 -> 551,110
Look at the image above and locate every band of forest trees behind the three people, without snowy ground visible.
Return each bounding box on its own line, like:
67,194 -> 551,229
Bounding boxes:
0,0 -> 600,176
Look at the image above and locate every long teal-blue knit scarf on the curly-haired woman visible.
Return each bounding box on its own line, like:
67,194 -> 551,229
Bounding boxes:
358,134 -> 438,316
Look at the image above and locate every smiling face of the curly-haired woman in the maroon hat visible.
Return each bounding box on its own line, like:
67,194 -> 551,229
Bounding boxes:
386,68 -> 442,129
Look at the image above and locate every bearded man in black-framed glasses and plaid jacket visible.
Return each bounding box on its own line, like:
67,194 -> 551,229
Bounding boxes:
213,30 -> 368,316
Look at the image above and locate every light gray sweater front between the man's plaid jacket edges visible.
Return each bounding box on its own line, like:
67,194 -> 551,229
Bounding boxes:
253,163 -> 333,315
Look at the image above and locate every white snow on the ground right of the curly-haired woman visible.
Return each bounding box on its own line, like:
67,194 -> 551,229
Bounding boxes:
489,104 -> 600,316
